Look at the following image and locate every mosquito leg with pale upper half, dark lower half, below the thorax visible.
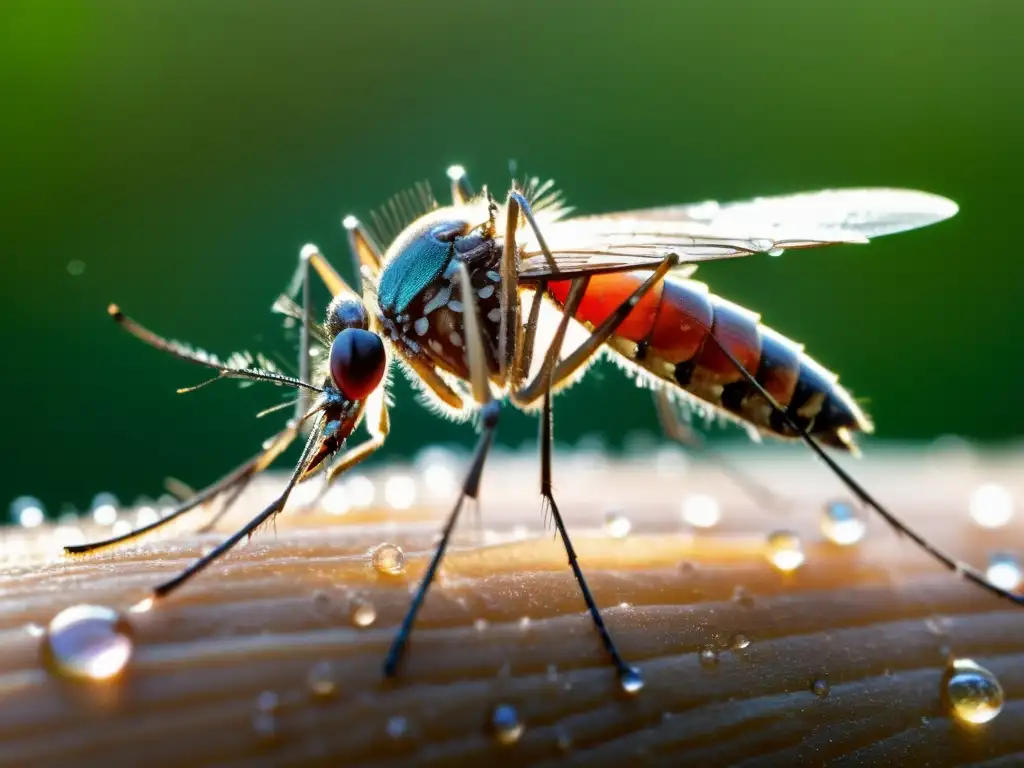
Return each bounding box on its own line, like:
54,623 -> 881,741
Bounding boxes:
384,263 -> 501,677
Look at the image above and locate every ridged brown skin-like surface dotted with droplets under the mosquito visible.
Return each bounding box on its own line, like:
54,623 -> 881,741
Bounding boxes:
0,451 -> 1024,767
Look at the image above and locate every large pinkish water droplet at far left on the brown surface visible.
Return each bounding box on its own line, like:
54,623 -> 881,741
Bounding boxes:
41,605 -> 134,680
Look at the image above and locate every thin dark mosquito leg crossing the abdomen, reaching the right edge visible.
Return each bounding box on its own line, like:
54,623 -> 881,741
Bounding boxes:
708,334 -> 1024,605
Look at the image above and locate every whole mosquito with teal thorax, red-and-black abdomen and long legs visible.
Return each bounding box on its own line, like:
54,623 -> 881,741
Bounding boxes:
67,160 -> 1024,683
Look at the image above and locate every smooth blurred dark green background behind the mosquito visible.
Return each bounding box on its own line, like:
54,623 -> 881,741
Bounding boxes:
0,0 -> 1024,518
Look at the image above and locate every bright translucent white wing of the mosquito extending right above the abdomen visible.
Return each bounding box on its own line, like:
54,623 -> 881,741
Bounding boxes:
520,187 -> 958,281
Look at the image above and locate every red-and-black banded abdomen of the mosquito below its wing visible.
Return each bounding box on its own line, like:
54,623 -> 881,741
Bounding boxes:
548,270 -> 872,450
